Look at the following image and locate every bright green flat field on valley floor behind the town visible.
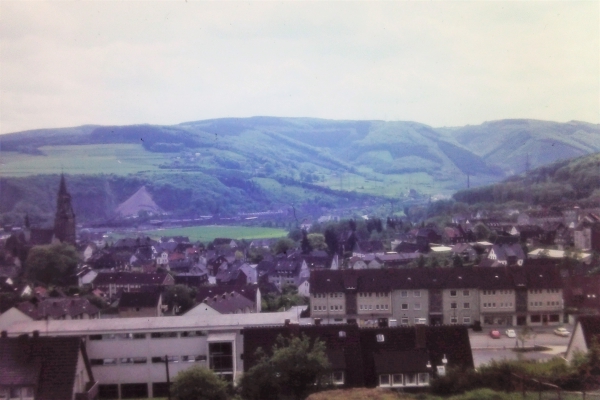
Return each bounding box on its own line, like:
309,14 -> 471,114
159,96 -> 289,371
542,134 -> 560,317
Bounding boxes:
123,225 -> 287,243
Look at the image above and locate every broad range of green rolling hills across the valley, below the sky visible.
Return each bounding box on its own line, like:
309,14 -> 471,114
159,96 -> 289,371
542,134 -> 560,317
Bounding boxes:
0,117 -> 600,225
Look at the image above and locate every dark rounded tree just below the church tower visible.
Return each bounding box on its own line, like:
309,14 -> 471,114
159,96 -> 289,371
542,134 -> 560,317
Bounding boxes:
25,243 -> 79,285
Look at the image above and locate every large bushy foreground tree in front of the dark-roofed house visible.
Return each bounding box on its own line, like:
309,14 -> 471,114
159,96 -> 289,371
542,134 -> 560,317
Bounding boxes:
240,335 -> 330,400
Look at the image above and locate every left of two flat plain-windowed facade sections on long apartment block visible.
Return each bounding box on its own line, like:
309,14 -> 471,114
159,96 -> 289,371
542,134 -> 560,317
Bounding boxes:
392,289 -> 429,325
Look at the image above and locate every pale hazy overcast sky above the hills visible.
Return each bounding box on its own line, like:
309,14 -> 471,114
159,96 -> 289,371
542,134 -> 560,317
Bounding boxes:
0,0 -> 600,133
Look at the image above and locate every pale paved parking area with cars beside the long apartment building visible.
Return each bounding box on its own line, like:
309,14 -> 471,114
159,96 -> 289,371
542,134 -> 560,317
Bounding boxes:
469,326 -> 573,368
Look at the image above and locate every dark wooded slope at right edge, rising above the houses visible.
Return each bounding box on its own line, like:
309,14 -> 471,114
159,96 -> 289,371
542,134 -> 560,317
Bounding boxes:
454,153 -> 600,206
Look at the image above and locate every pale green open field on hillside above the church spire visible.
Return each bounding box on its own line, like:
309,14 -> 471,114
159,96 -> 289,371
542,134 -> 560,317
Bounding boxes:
0,144 -> 169,176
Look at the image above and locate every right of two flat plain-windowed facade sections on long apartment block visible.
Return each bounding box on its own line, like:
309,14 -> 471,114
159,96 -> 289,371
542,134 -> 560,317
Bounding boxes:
442,289 -> 480,325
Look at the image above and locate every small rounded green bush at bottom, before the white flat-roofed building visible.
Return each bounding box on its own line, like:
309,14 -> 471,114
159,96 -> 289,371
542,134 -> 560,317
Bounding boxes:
171,366 -> 228,400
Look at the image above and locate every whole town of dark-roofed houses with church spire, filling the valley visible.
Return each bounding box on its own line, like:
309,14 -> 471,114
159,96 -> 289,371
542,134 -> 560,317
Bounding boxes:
0,175 -> 600,399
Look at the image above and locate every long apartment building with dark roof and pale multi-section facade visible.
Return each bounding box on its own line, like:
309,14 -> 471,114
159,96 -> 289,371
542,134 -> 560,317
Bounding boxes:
310,265 -> 564,326
